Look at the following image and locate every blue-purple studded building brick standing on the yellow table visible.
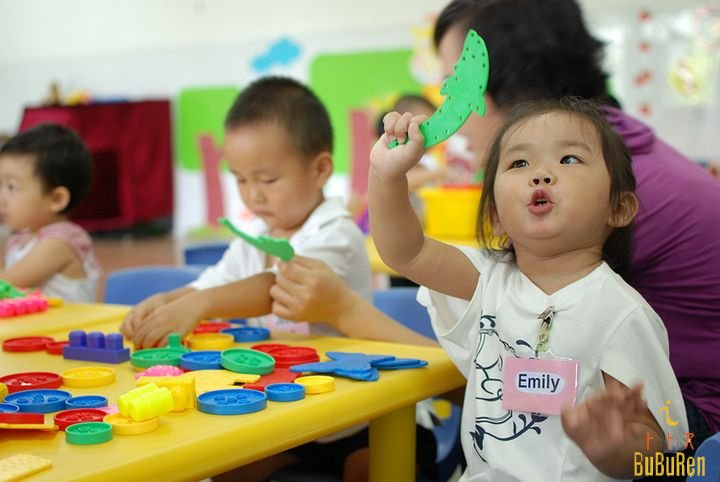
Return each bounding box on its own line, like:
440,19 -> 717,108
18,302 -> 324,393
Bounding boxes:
63,330 -> 130,363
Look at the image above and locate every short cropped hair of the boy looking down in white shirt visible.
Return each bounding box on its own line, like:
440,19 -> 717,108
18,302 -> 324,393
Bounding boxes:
225,77 -> 333,158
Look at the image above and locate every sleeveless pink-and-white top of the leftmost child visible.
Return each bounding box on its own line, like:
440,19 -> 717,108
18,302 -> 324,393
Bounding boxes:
5,221 -> 101,303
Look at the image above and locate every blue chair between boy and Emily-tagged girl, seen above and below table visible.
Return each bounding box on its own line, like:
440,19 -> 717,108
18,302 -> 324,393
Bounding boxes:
373,287 -> 462,480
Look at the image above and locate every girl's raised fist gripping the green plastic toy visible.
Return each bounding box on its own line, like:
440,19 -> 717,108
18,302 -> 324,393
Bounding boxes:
370,112 -> 427,177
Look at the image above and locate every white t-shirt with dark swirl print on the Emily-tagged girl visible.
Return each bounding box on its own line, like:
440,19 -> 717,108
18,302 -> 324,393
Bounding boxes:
418,248 -> 688,482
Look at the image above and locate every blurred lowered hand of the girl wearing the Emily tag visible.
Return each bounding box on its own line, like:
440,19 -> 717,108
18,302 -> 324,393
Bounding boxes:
561,377 -> 662,467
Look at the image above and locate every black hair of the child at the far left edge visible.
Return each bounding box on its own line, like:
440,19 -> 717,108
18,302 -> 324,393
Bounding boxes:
0,124 -> 92,214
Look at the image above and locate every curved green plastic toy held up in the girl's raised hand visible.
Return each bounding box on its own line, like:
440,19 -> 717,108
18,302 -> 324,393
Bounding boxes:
389,29 -> 490,149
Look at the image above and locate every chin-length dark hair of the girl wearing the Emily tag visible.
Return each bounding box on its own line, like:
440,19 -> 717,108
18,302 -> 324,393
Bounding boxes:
477,97 -> 635,275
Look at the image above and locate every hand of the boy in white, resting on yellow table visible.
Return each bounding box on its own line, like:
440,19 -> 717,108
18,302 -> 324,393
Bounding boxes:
132,296 -> 201,350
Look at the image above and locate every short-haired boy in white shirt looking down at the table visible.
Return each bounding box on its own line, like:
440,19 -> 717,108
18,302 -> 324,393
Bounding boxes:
121,77 -> 372,348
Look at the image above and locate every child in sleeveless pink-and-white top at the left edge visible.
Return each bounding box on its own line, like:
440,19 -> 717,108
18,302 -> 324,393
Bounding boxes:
0,124 -> 100,303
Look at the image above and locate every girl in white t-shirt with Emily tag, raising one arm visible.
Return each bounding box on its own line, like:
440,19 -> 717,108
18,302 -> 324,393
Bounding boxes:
369,100 -> 687,481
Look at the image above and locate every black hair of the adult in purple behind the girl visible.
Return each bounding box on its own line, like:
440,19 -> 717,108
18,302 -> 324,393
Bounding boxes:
434,0 -> 608,109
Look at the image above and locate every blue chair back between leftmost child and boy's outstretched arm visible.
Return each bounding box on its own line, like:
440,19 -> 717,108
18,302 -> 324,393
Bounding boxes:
103,265 -> 205,305
